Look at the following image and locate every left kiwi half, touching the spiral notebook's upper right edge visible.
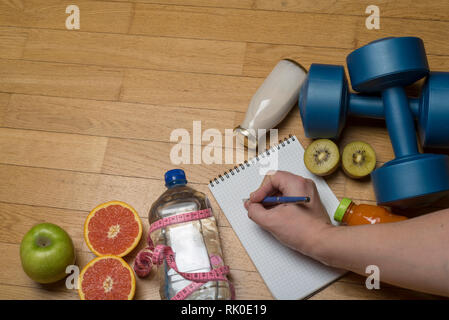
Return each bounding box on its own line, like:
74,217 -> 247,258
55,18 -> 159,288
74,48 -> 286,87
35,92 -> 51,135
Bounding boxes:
304,139 -> 340,176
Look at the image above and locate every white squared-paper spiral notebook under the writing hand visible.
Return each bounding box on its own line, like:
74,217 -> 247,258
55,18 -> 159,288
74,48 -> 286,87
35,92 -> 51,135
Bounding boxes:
209,136 -> 344,300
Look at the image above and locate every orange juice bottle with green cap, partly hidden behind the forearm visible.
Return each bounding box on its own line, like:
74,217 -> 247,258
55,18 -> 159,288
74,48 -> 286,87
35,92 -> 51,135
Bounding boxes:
334,198 -> 407,226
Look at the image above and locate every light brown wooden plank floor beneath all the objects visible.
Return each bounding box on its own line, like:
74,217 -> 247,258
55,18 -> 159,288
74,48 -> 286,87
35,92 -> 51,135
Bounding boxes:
0,0 -> 449,299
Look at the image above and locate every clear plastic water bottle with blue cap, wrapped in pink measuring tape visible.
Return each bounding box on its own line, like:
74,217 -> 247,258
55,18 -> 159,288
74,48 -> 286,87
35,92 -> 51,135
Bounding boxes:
149,169 -> 231,300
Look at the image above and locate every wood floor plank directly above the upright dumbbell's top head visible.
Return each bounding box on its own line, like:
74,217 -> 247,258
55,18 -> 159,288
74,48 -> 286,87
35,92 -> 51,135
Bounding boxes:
356,17 -> 449,55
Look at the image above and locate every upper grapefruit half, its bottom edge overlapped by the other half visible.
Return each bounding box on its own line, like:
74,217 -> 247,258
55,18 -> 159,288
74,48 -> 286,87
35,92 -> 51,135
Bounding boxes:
84,201 -> 142,257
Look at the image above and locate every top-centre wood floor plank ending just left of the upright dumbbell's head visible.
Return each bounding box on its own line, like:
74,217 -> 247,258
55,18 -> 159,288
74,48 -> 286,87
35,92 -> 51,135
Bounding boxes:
130,3 -> 356,48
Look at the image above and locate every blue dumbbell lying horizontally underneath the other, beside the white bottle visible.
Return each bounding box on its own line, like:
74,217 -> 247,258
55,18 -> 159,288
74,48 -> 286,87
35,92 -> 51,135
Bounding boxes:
299,64 -> 449,148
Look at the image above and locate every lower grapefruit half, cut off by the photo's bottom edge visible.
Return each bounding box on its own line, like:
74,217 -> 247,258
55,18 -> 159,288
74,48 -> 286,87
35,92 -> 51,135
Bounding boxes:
78,256 -> 136,300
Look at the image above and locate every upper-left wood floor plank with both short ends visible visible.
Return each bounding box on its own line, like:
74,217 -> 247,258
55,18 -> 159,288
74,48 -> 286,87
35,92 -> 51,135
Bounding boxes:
21,29 -> 246,75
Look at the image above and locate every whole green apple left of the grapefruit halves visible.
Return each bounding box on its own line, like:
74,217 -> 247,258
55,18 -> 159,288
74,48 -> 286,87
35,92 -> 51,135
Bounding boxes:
20,223 -> 75,283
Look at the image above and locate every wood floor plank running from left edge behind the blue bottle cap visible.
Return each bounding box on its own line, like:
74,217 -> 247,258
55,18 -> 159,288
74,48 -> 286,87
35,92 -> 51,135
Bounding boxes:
0,164 -> 229,226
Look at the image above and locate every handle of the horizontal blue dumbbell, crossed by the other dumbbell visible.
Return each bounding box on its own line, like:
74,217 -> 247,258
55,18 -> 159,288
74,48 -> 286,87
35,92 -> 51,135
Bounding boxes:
348,93 -> 419,119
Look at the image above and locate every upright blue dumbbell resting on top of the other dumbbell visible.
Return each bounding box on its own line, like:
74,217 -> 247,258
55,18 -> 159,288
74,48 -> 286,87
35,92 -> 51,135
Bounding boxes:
346,37 -> 449,208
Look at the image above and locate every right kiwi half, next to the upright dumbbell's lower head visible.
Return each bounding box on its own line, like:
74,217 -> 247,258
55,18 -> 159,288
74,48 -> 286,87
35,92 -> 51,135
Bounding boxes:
341,141 -> 376,179
